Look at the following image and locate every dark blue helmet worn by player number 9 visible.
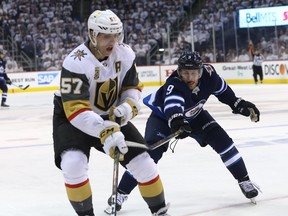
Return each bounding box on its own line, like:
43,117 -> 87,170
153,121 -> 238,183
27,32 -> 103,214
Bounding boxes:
177,51 -> 202,77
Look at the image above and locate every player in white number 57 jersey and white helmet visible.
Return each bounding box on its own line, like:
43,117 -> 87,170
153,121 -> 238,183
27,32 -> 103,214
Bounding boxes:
53,10 -> 168,216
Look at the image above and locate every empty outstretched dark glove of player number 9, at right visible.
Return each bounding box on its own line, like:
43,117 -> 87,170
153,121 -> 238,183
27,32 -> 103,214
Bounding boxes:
232,98 -> 260,122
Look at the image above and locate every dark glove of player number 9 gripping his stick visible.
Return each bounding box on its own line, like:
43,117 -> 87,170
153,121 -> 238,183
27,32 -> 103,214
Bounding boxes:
168,113 -> 192,139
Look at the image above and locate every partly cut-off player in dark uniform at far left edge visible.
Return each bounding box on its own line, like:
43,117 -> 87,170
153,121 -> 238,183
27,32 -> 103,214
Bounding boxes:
0,51 -> 12,107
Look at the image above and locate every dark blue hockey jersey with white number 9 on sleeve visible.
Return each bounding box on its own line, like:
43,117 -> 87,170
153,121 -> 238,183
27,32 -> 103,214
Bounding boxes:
143,64 -> 237,121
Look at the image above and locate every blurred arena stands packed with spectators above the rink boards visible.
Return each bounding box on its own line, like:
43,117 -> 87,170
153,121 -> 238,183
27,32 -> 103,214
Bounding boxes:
0,0 -> 288,73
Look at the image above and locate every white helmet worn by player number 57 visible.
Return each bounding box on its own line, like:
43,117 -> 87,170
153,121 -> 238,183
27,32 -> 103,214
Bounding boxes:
88,10 -> 124,46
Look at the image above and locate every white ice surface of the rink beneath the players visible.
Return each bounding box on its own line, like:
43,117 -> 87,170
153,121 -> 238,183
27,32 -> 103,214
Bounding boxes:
0,84 -> 288,216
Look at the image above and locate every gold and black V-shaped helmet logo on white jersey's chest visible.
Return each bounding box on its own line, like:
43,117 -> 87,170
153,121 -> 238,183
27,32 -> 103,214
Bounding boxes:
94,77 -> 118,111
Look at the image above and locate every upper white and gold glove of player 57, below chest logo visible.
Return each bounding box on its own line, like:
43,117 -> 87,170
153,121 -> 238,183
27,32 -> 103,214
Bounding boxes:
109,98 -> 141,126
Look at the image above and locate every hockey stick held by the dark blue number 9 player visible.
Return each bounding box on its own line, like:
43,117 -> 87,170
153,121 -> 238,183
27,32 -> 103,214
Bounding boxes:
126,129 -> 183,151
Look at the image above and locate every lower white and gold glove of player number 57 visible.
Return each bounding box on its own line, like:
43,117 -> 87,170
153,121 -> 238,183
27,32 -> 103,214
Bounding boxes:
96,121 -> 128,160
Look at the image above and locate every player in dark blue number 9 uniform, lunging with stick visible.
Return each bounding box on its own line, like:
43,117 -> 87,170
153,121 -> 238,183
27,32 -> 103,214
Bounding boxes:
108,51 -> 260,214
